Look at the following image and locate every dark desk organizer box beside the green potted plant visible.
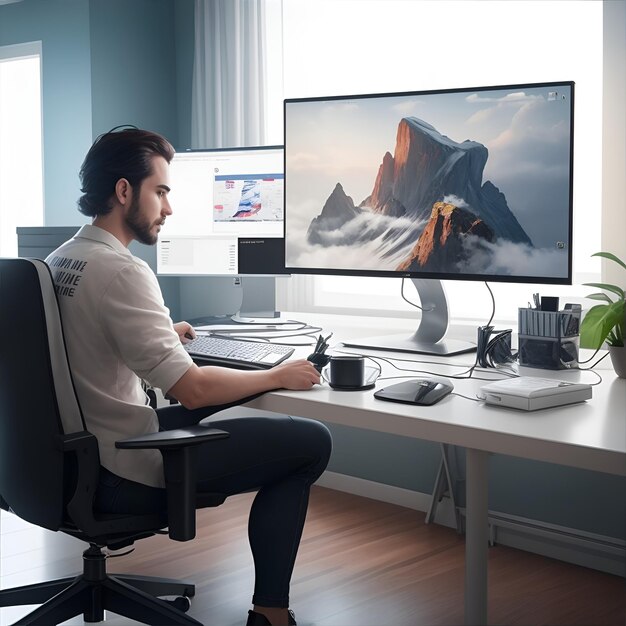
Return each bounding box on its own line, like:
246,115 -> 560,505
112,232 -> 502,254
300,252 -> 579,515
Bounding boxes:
518,309 -> 580,370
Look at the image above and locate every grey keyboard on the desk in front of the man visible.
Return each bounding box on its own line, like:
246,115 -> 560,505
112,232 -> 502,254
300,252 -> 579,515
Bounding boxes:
185,335 -> 294,369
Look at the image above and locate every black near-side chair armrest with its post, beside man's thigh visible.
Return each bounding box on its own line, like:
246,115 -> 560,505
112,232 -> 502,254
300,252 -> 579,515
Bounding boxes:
115,424 -> 230,541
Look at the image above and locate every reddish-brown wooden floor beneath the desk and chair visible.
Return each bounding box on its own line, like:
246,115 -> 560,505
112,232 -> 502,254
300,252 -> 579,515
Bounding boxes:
0,487 -> 626,626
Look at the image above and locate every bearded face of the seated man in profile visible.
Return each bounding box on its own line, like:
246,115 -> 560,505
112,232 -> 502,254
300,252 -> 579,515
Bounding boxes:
126,156 -> 172,246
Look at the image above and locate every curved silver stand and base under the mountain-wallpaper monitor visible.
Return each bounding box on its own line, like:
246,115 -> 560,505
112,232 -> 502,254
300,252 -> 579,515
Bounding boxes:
343,278 -> 476,356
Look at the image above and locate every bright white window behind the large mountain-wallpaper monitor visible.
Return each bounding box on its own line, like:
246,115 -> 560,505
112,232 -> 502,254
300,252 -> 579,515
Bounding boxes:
278,0 -> 603,321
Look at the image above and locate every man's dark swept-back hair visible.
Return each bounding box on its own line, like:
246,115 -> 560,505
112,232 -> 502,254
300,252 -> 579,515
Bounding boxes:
78,126 -> 174,217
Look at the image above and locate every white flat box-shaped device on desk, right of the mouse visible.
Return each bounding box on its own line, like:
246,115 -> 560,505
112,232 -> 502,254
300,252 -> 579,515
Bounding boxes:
479,376 -> 591,411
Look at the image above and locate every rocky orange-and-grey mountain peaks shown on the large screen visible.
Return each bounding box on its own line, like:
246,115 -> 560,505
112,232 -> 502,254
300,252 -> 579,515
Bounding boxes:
307,117 -> 533,273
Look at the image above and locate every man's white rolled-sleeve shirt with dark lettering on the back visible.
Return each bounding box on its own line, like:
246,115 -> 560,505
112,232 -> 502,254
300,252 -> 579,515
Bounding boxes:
46,225 -> 192,487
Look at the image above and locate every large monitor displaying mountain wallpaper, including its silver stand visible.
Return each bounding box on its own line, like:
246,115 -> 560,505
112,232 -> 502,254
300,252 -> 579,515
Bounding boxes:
284,82 -> 574,355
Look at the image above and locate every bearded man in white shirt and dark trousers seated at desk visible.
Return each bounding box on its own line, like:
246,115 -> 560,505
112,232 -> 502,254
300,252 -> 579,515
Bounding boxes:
47,128 -> 331,626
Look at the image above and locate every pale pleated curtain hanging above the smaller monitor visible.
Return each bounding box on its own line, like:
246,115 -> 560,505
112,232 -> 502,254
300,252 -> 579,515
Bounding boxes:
191,0 -> 266,148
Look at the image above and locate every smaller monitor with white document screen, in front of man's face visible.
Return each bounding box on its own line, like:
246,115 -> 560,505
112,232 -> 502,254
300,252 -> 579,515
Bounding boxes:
157,146 -> 286,321
